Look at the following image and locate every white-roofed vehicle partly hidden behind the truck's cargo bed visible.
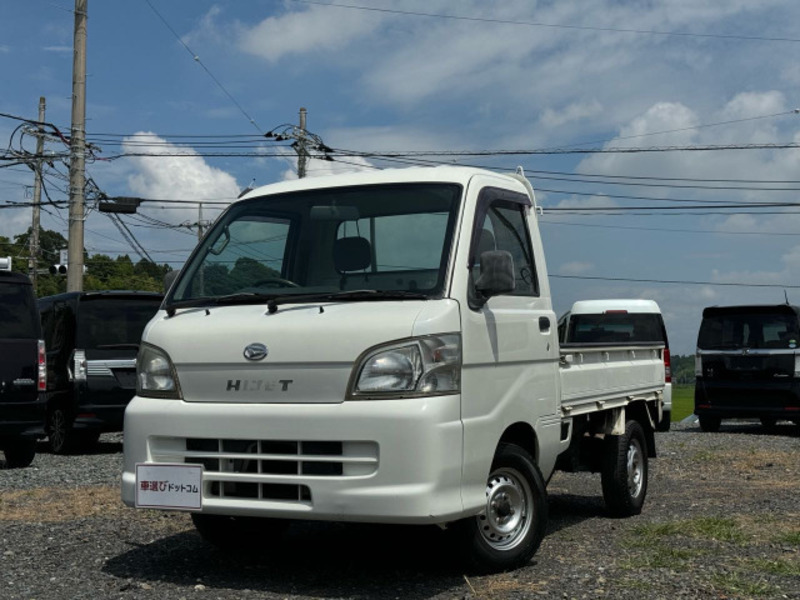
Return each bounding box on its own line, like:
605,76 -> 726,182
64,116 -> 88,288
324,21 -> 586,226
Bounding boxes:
558,299 -> 672,431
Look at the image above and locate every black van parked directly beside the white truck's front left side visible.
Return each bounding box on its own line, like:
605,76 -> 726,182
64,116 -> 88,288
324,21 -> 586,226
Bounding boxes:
39,291 -> 163,454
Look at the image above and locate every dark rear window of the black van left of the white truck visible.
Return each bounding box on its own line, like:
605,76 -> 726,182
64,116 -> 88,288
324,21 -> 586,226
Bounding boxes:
77,296 -> 161,358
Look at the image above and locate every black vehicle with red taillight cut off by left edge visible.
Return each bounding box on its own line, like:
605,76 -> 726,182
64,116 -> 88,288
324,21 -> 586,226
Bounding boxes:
0,268 -> 46,467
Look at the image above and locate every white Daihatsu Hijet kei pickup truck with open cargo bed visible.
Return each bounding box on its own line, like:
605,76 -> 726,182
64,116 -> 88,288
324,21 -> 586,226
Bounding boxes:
122,167 -> 664,572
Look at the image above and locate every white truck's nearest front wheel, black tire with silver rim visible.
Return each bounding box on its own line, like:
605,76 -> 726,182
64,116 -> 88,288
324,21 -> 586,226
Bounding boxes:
454,444 -> 547,573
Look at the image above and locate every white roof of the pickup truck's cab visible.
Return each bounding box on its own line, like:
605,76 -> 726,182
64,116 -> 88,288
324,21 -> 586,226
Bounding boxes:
241,166 -> 526,200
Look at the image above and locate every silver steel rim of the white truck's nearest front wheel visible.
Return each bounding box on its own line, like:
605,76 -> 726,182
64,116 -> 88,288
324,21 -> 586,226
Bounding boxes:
476,469 -> 533,550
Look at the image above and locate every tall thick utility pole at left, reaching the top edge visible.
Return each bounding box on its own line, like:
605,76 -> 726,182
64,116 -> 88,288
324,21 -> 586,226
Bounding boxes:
67,0 -> 89,292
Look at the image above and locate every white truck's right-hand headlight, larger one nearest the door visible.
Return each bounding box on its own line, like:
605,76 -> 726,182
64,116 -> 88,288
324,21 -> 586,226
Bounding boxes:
348,333 -> 461,398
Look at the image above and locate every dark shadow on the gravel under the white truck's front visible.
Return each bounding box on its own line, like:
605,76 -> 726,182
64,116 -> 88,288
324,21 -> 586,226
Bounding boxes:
103,522 -> 472,599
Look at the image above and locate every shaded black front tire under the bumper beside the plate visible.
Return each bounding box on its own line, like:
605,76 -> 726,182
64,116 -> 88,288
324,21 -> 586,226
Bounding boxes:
192,513 -> 290,553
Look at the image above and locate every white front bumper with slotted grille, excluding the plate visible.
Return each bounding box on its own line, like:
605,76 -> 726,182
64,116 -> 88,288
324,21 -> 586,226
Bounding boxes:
122,395 -> 466,524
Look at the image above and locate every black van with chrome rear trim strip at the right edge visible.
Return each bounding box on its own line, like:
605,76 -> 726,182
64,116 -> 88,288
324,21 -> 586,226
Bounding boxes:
694,304 -> 800,431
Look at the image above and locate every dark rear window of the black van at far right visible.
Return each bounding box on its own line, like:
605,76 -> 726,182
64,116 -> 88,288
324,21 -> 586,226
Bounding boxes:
697,311 -> 800,350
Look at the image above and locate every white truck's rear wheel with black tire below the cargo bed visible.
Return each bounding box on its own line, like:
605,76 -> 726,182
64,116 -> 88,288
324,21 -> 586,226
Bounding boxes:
601,421 -> 648,517
